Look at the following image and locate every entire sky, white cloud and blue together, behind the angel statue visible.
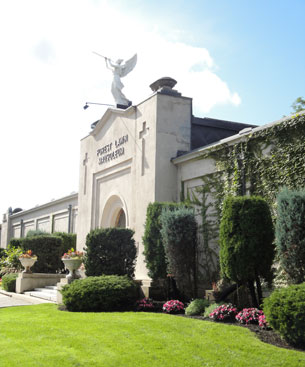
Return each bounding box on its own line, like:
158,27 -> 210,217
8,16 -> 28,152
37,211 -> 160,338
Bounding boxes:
0,0 -> 305,213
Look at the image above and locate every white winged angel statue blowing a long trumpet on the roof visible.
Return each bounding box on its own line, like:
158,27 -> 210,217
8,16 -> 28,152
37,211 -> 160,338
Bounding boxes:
94,52 -> 137,106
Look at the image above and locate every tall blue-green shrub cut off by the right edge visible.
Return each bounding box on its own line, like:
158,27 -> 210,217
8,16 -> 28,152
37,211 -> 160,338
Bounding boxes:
276,189 -> 305,284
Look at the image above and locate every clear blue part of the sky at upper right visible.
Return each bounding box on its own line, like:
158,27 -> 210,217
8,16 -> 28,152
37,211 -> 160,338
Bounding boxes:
130,0 -> 305,125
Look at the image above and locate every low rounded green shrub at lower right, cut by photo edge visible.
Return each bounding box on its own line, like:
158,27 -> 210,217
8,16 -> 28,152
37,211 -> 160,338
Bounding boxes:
263,283 -> 305,346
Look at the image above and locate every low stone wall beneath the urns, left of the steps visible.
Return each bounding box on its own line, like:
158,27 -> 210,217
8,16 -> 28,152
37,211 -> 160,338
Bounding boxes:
16,273 -> 66,293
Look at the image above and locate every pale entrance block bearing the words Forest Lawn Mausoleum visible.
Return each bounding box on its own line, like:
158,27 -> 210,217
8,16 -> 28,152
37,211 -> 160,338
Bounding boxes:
77,93 -> 191,279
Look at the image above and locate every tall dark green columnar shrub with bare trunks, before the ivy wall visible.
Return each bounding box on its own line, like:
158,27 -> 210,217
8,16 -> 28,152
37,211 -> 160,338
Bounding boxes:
219,196 -> 274,306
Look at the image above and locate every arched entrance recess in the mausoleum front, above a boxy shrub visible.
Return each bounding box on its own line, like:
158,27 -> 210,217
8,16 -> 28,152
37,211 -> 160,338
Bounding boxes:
101,195 -> 128,228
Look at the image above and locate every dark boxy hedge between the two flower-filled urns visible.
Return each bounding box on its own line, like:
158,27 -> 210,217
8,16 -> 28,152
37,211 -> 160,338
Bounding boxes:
20,235 -> 62,273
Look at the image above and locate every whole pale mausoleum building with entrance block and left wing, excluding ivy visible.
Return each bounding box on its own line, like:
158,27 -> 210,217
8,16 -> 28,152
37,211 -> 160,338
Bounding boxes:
1,78 -> 255,279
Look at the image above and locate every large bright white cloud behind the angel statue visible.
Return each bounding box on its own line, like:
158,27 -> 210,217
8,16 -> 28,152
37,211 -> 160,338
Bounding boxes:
0,0 -> 241,211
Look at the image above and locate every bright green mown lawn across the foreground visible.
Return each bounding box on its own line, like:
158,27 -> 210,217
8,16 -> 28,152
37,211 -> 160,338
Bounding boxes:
0,304 -> 305,367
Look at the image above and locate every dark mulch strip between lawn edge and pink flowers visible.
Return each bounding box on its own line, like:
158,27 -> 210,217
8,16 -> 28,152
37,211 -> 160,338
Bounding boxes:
177,314 -> 305,352
